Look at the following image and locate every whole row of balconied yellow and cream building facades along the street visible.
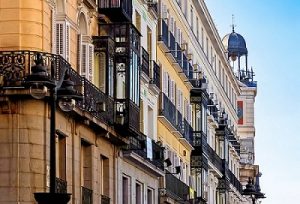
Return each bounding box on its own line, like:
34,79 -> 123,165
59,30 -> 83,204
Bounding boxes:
0,0 -> 259,204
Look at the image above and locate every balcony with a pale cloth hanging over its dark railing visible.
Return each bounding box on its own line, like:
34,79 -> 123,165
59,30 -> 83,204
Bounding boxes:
123,133 -> 164,176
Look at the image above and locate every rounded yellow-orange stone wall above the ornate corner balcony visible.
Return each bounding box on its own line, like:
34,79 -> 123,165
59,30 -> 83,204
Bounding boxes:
0,0 -> 51,52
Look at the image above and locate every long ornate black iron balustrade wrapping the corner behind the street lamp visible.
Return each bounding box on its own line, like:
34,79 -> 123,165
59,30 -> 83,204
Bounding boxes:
0,51 -> 114,124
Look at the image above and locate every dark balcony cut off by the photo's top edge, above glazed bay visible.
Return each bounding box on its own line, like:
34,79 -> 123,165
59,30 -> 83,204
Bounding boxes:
98,0 -> 132,22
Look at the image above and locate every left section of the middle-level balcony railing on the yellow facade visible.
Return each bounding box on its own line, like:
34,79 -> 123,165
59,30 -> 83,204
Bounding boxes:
160,93 -> 177,128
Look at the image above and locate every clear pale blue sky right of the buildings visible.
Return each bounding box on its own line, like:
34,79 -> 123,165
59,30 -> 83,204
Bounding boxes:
205,0 -> 300,204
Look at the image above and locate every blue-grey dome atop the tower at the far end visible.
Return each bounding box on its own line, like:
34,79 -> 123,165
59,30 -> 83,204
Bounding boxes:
222,30 -> 248,57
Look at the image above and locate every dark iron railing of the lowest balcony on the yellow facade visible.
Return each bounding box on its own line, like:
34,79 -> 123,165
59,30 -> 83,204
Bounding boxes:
165,170 -> 189,201
